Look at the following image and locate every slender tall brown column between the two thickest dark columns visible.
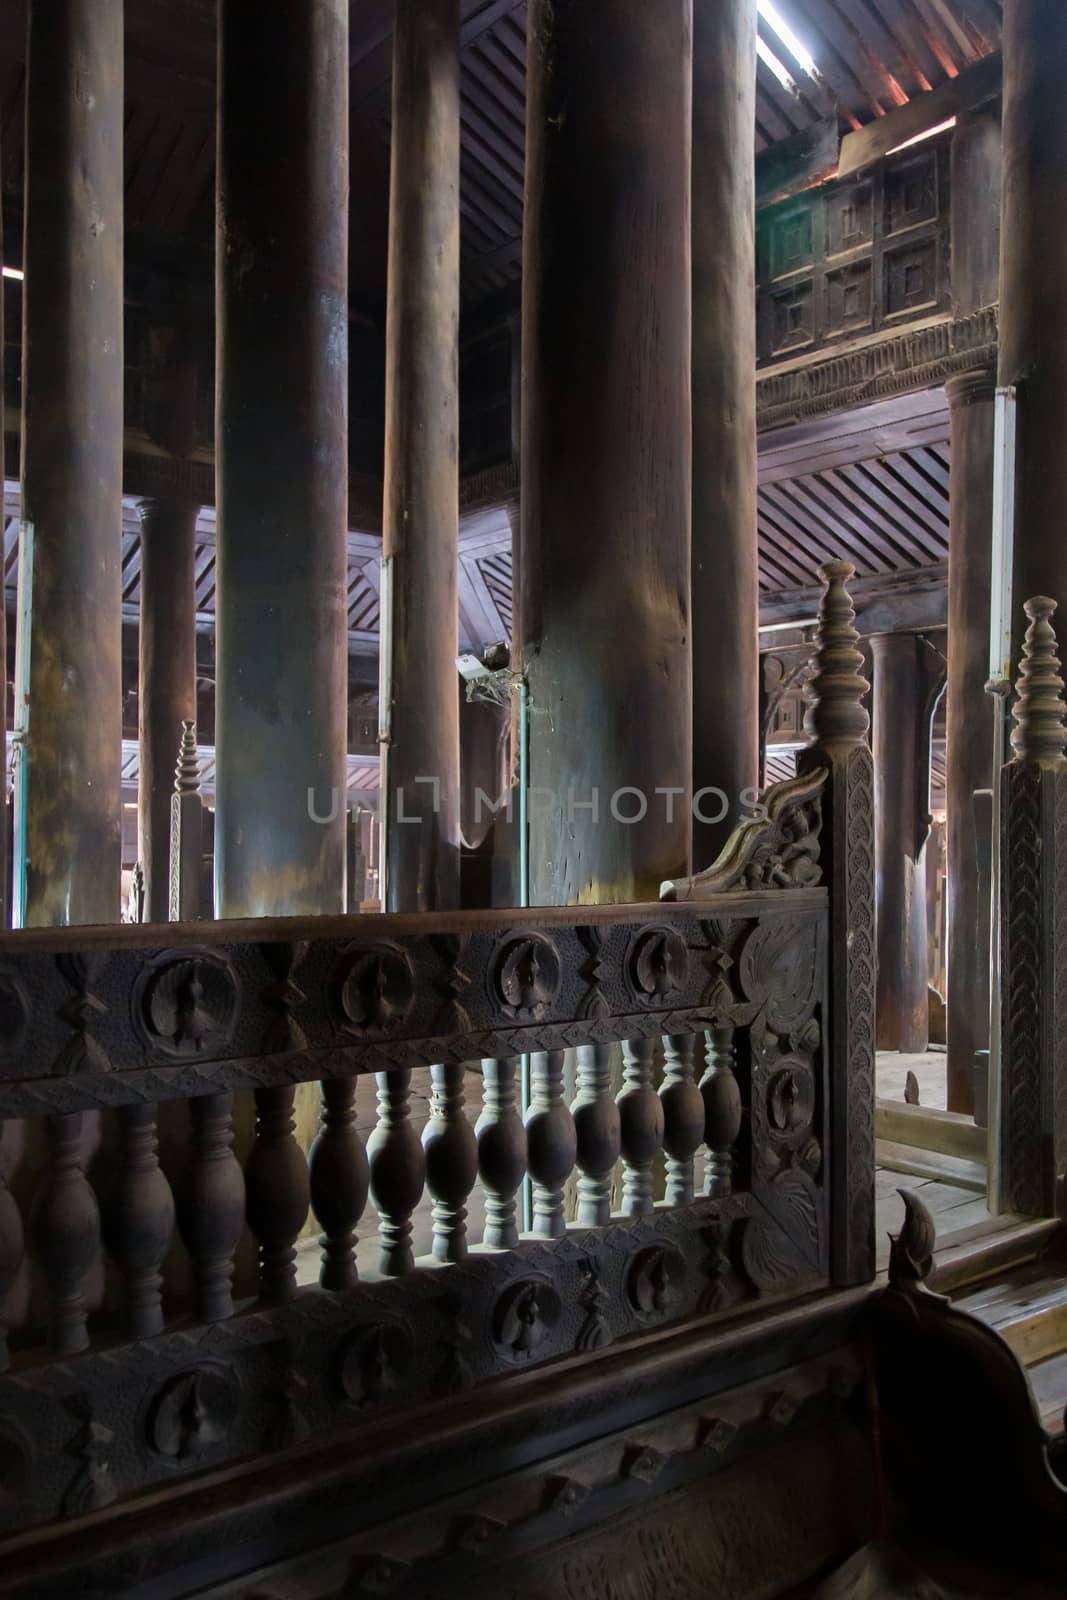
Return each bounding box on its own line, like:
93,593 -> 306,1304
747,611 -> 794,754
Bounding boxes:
382,0 -> 459,910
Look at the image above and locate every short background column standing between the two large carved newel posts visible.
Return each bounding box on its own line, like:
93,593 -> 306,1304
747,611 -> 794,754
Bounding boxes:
870,634 -> 929,1050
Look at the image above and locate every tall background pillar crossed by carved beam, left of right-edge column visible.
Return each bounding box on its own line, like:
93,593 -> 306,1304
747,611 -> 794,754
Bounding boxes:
945,109 -> 1000,1115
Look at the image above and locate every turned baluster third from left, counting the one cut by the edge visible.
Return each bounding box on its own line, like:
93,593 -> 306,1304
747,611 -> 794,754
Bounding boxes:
106,1106 -> 174,1339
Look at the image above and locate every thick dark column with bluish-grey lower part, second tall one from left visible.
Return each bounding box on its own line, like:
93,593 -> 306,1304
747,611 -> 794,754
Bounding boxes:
214,0 -> 349,917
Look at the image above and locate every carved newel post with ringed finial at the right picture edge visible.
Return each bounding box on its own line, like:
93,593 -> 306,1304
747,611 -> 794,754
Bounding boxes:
1000,595 -> 1067,1216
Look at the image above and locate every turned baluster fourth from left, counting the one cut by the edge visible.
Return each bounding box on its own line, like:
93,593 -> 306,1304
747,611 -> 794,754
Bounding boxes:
178,1094 -> 245,1322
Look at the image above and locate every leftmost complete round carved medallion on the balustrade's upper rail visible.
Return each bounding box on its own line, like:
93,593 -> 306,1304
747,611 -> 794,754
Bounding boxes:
131,950 -> 240,1059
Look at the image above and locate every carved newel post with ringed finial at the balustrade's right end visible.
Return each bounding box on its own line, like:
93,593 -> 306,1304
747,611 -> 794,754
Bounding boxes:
798,562 -> 875,1283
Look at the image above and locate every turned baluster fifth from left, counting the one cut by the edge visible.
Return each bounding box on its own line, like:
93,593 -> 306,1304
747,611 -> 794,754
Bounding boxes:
245,1085 -> 310,1306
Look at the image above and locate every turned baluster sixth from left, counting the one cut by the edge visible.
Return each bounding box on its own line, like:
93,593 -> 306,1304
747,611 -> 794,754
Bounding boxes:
307,1078 -> 371,1290
